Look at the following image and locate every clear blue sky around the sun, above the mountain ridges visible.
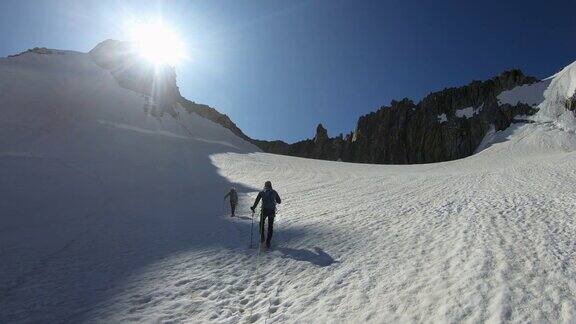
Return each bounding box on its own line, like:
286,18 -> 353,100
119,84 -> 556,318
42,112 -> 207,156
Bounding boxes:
0,0 -> 576,142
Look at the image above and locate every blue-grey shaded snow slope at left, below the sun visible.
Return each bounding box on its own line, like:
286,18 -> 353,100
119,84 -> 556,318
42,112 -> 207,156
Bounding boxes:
0,46 -> 259,323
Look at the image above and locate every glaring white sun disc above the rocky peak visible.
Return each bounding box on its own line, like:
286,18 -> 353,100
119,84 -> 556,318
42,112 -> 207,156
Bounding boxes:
129,23 -> 185,65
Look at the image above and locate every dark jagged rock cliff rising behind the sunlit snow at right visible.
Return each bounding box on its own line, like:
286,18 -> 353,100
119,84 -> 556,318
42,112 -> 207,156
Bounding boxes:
255,70 -> 537,164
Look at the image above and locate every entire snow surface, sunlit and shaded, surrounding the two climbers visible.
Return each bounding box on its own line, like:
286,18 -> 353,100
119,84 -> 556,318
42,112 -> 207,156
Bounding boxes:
0,48 -> 576,323
